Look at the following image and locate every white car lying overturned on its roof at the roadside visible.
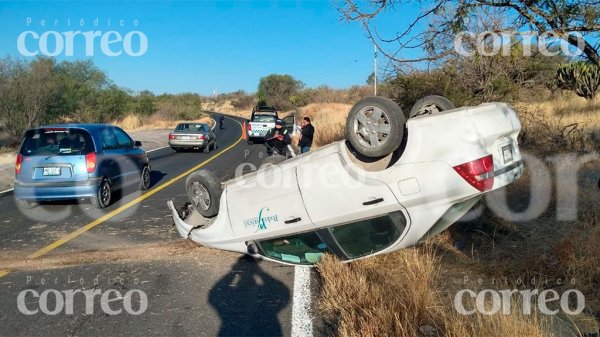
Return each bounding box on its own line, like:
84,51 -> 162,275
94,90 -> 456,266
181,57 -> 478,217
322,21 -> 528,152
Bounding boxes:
168,96 -> 523,264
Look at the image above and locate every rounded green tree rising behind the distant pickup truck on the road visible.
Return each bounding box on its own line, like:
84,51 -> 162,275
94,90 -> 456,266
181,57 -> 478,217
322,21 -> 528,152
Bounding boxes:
256,74 -> 304,110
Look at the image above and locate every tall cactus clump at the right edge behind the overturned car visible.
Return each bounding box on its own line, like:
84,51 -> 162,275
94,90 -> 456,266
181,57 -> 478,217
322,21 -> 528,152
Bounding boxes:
556,62 -> 600,99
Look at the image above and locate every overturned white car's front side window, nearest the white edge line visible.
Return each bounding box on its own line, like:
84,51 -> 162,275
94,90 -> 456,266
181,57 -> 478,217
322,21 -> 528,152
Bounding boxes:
258,232 -> 330,264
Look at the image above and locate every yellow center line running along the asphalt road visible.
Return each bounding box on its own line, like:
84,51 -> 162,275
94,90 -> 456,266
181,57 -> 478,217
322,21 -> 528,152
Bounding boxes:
0,118 -> 245,278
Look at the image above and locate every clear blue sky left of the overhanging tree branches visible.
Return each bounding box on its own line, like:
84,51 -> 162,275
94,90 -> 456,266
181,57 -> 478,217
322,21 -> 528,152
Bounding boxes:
0,1 -> 412,94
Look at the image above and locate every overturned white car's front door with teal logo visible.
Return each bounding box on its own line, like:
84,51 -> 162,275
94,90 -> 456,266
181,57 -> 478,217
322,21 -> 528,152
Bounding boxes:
226,163 -> 314,241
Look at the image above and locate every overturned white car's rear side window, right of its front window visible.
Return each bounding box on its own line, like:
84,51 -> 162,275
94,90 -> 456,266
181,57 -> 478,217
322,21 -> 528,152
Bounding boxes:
329,212 -> 406,259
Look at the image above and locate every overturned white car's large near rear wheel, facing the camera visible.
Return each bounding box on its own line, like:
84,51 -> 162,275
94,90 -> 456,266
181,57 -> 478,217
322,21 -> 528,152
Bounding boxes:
346,97 -> 406,158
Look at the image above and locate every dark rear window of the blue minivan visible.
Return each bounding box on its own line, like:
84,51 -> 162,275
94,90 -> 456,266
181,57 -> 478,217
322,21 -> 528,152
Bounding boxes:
19,128 -> 94,156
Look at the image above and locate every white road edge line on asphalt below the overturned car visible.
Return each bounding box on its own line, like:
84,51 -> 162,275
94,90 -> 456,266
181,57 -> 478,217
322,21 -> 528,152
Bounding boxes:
292,266 -> 313,337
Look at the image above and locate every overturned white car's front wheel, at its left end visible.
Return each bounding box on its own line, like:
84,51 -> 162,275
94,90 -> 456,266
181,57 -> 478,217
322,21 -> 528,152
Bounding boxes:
185,170 -> 223,217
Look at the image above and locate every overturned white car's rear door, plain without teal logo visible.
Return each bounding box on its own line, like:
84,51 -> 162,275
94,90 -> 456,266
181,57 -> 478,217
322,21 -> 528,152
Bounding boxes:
297,151 -> 404,228
